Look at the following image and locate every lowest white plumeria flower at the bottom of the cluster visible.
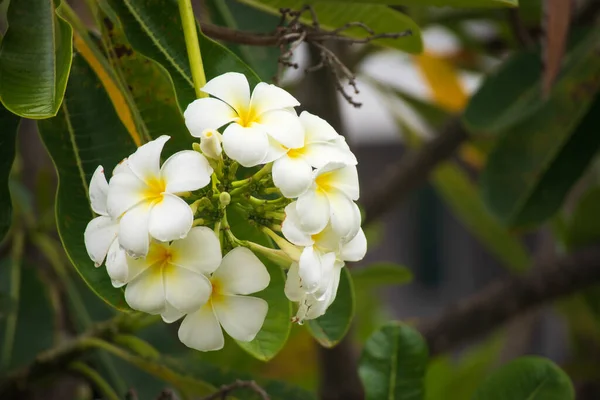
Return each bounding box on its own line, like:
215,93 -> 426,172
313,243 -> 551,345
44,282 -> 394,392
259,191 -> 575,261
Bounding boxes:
179,247 -> 270,351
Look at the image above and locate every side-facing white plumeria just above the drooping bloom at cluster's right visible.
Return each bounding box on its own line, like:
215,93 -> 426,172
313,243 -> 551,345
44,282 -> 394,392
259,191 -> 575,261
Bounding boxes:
281,203 -> 367,300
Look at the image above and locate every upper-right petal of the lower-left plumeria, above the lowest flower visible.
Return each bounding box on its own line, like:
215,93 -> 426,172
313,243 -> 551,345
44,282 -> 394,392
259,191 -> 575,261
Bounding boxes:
171,226 -> 222,275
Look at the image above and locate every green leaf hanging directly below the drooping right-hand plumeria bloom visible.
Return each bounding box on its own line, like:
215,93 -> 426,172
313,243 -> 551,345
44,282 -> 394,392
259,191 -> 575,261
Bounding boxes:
306,268 -> 355,347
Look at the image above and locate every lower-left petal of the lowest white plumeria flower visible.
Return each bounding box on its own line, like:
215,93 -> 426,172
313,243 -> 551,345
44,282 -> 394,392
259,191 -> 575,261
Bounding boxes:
178,302 -> 225,351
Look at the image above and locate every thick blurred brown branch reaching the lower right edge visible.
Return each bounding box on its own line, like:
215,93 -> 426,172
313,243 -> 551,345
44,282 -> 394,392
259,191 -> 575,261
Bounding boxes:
418,245 -> 600,354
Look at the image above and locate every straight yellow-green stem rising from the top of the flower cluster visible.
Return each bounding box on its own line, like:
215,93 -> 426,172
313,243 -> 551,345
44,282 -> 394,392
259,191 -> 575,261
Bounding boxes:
177,0 -> 207,98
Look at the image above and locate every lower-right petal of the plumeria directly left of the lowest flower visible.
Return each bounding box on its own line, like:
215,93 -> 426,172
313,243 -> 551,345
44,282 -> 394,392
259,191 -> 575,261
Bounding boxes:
164,265 -> 212,313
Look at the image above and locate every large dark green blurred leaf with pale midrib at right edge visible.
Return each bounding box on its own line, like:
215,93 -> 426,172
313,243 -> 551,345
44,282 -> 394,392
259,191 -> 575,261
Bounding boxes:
481,29 -> 600,227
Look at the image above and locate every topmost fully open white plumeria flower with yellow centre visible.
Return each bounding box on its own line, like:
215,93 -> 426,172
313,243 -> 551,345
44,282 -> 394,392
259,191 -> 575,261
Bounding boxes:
183,72 -> 304,167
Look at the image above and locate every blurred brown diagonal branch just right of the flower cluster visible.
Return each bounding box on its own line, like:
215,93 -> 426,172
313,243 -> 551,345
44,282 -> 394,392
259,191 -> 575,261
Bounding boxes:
362,117 -> 467,225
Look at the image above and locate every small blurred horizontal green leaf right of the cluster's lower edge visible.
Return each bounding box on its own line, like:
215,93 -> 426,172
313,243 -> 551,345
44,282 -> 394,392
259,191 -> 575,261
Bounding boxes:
351,262 -> 413,290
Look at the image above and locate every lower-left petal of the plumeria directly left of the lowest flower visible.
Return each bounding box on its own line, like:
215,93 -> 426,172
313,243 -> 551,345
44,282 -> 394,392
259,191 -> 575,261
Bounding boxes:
125,266 -> 165,314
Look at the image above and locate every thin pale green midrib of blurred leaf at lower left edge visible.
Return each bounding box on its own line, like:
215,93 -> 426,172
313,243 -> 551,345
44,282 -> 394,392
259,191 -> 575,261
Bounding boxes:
0,226 -> 25,370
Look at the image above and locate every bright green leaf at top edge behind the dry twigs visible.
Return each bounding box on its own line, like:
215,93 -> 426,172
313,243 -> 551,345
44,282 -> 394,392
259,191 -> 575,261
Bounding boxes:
234,0 -> 423,53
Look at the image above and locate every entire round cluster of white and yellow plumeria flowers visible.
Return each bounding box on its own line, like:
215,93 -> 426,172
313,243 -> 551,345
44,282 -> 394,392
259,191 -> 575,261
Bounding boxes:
84,73 -> 366,351
